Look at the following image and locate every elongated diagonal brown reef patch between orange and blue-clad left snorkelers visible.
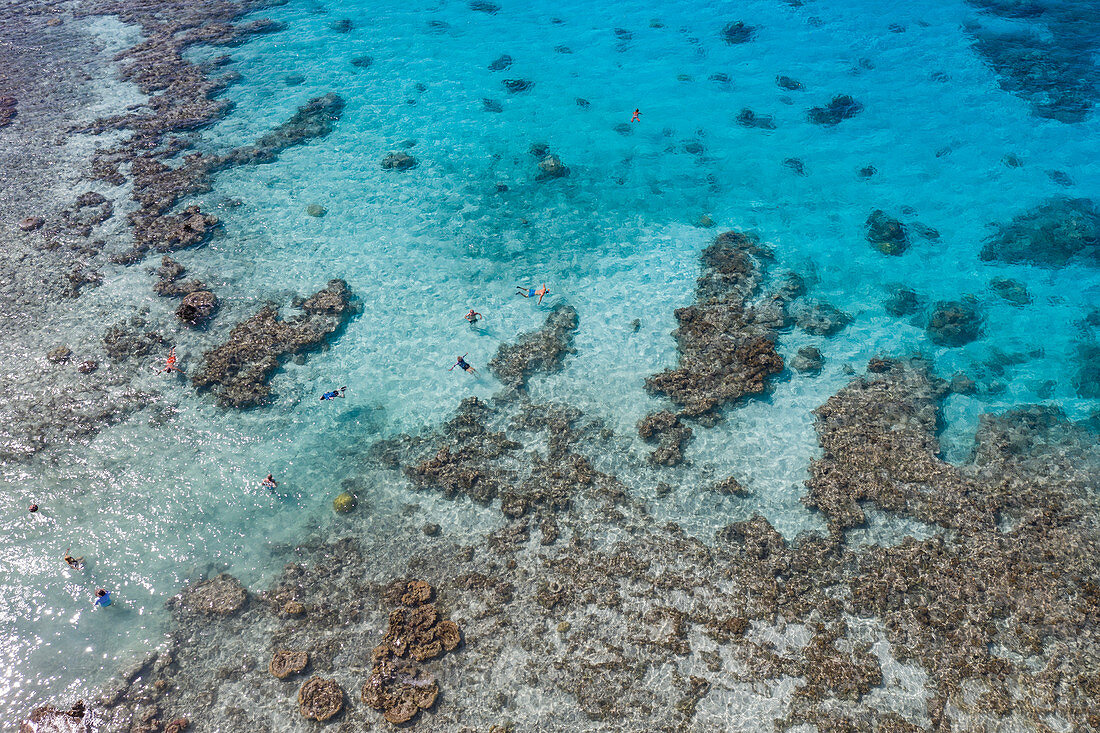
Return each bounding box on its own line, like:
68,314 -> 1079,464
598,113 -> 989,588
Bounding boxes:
191,280 -> 354,408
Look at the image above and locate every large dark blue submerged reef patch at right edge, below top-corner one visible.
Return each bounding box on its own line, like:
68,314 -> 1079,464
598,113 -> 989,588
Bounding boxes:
981,198 -> 1100,267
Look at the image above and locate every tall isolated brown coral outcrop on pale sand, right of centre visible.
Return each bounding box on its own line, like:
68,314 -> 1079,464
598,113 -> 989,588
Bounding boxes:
646,231 -> 787,417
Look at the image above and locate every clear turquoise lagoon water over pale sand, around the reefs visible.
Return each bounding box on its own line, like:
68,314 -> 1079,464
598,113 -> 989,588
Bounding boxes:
0,0 -> 1100,720
